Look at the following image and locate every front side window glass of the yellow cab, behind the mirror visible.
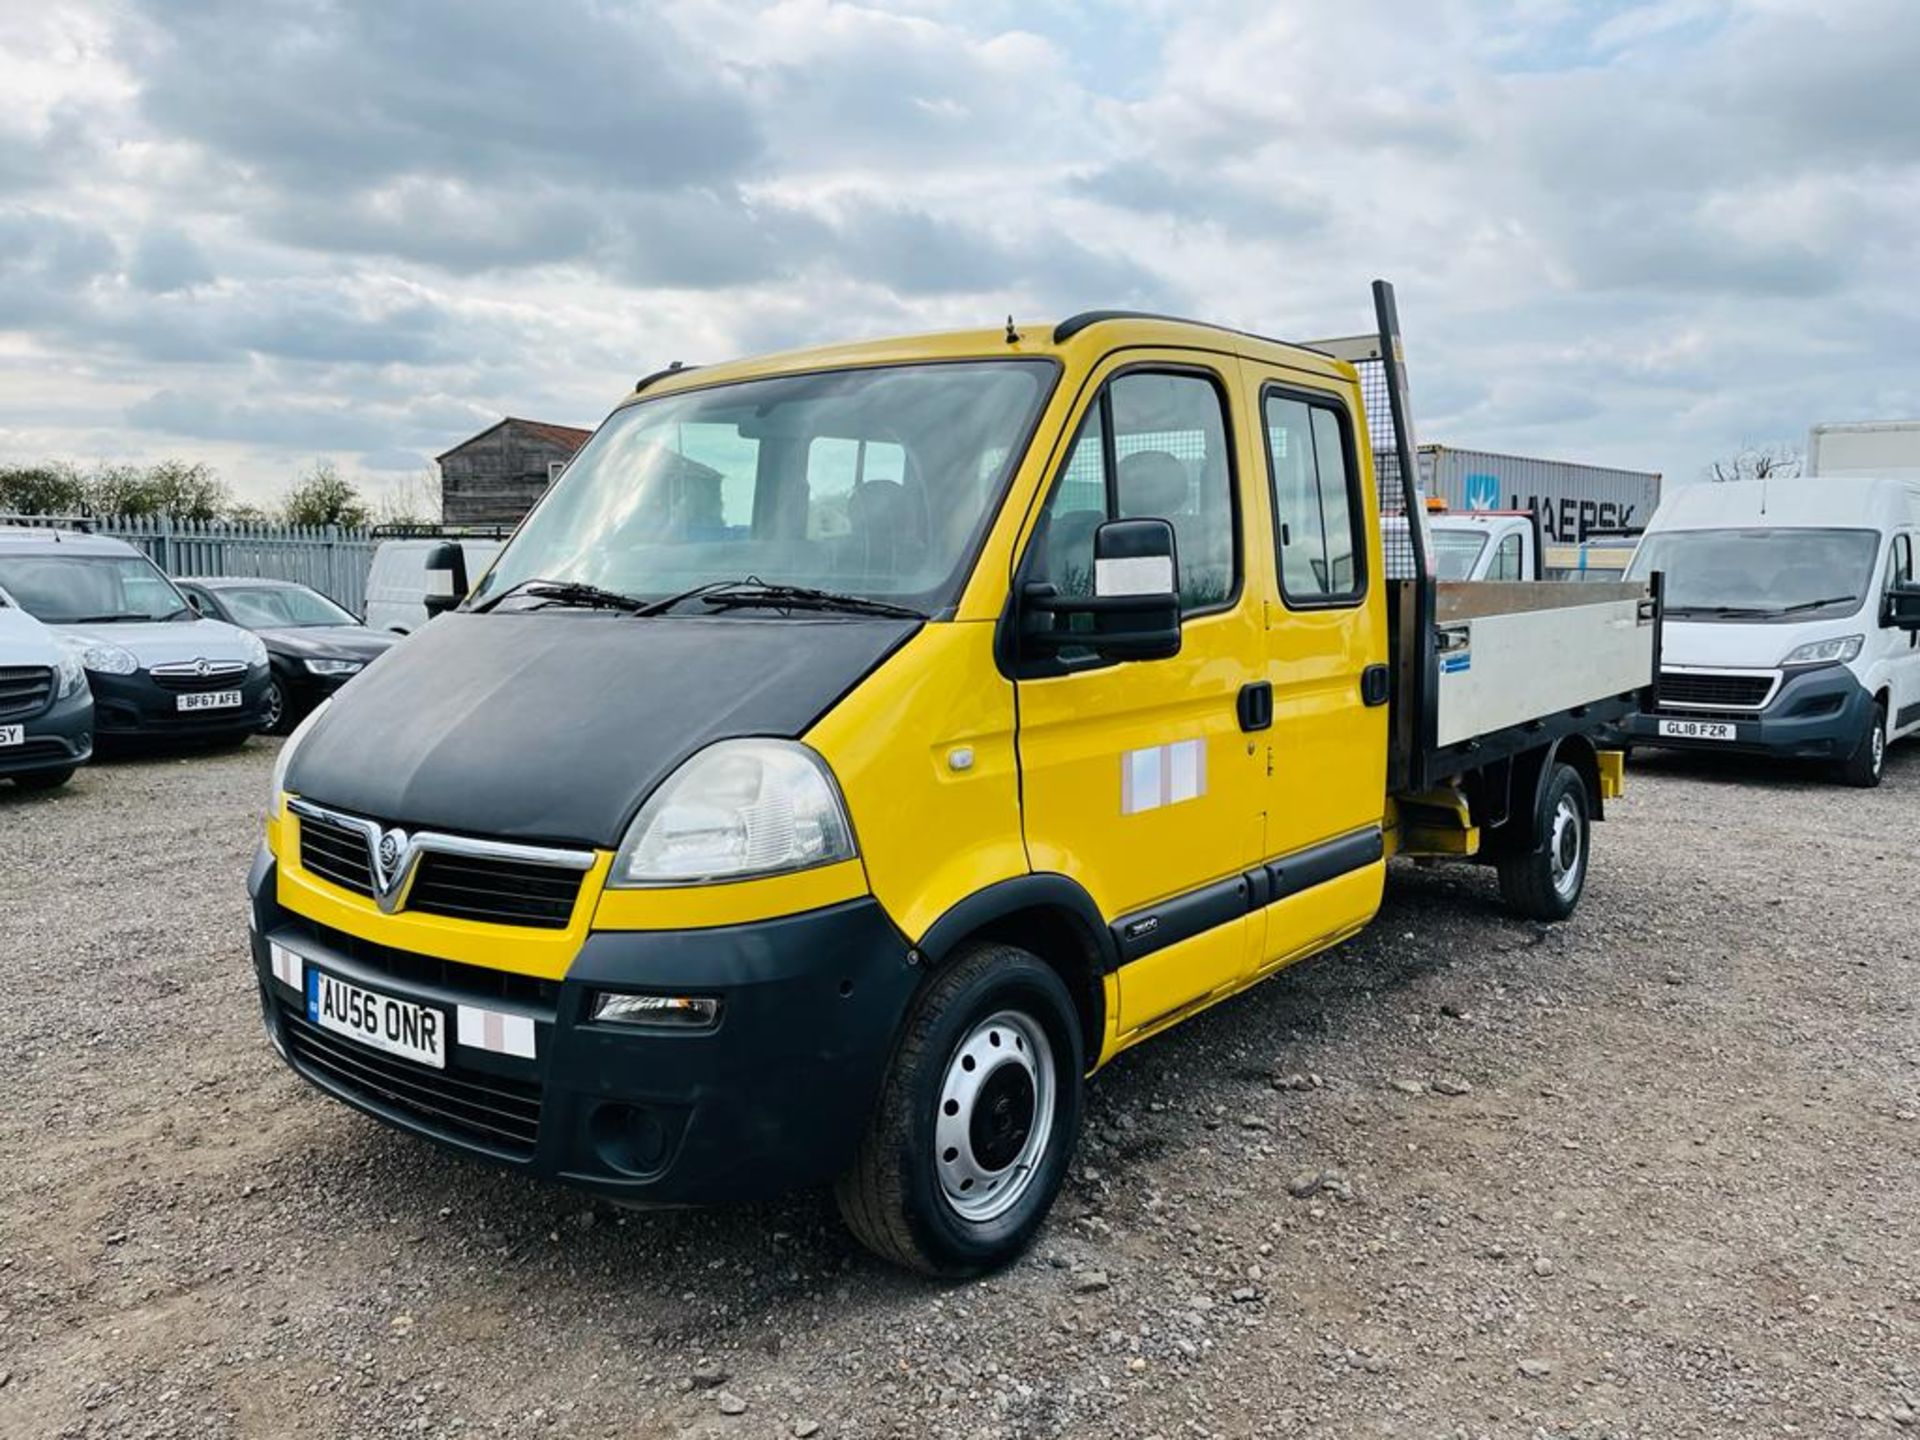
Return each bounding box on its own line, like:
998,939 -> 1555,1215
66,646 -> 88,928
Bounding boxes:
1033,371 -> 1240,614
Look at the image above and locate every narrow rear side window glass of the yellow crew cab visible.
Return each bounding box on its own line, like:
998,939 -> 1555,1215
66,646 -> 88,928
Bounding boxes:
1261,390 -> 1367,605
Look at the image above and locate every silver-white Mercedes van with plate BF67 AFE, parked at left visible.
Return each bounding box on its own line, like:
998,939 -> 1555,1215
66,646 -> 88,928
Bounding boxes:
0,530 -> 271,743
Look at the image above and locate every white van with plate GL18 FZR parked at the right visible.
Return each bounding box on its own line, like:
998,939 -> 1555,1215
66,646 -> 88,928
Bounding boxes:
1626,476 -> 1920,785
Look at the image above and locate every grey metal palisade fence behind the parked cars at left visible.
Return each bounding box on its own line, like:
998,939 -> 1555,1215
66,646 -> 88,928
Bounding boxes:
0,515 -> 380,614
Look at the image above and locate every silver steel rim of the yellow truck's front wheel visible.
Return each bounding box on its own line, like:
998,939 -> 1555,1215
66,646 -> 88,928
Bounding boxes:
933,1010 -> 1060,1225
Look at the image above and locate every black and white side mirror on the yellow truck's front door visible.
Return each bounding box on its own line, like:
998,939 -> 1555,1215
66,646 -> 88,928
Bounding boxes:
1021,518 -> 1181,660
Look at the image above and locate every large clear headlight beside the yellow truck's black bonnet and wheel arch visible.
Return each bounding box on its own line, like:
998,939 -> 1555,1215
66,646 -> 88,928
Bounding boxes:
607,739 -> 854,885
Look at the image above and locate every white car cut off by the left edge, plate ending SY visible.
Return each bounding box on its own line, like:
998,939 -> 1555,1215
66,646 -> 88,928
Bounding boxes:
0,593 -> 94,789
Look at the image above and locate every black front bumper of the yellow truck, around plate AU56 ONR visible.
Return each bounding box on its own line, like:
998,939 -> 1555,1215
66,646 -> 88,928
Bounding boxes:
252,851 -> 920,1204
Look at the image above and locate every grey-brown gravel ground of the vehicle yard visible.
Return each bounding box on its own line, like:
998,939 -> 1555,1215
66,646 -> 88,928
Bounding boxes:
0,741 -> 1920,1440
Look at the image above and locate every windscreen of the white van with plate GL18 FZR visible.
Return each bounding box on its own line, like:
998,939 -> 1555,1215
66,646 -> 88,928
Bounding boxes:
1626,528 -> 1880,622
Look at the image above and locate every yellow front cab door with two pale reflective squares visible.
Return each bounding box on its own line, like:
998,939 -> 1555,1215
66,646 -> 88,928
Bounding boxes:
1014,351 -> 1265,1037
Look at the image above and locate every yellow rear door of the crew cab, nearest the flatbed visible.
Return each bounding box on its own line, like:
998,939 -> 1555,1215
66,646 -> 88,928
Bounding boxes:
1248,365 -> 1388,966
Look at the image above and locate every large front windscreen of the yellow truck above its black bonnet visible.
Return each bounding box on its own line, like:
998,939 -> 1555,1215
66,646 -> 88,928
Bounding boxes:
472,361 -> 1054,612
